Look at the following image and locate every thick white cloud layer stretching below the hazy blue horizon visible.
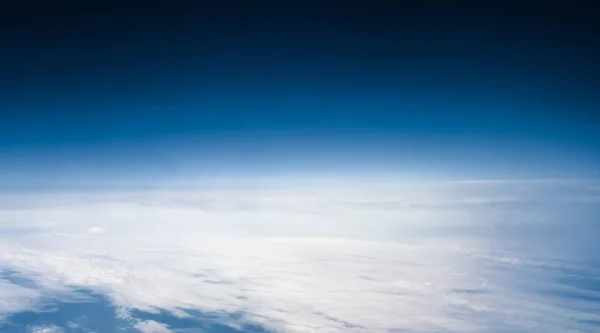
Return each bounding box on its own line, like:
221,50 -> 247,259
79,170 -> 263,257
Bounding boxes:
0,181 -> 600,333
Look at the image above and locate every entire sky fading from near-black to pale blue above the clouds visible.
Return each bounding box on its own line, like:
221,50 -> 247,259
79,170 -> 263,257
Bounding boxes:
0,1 -> 600,184
